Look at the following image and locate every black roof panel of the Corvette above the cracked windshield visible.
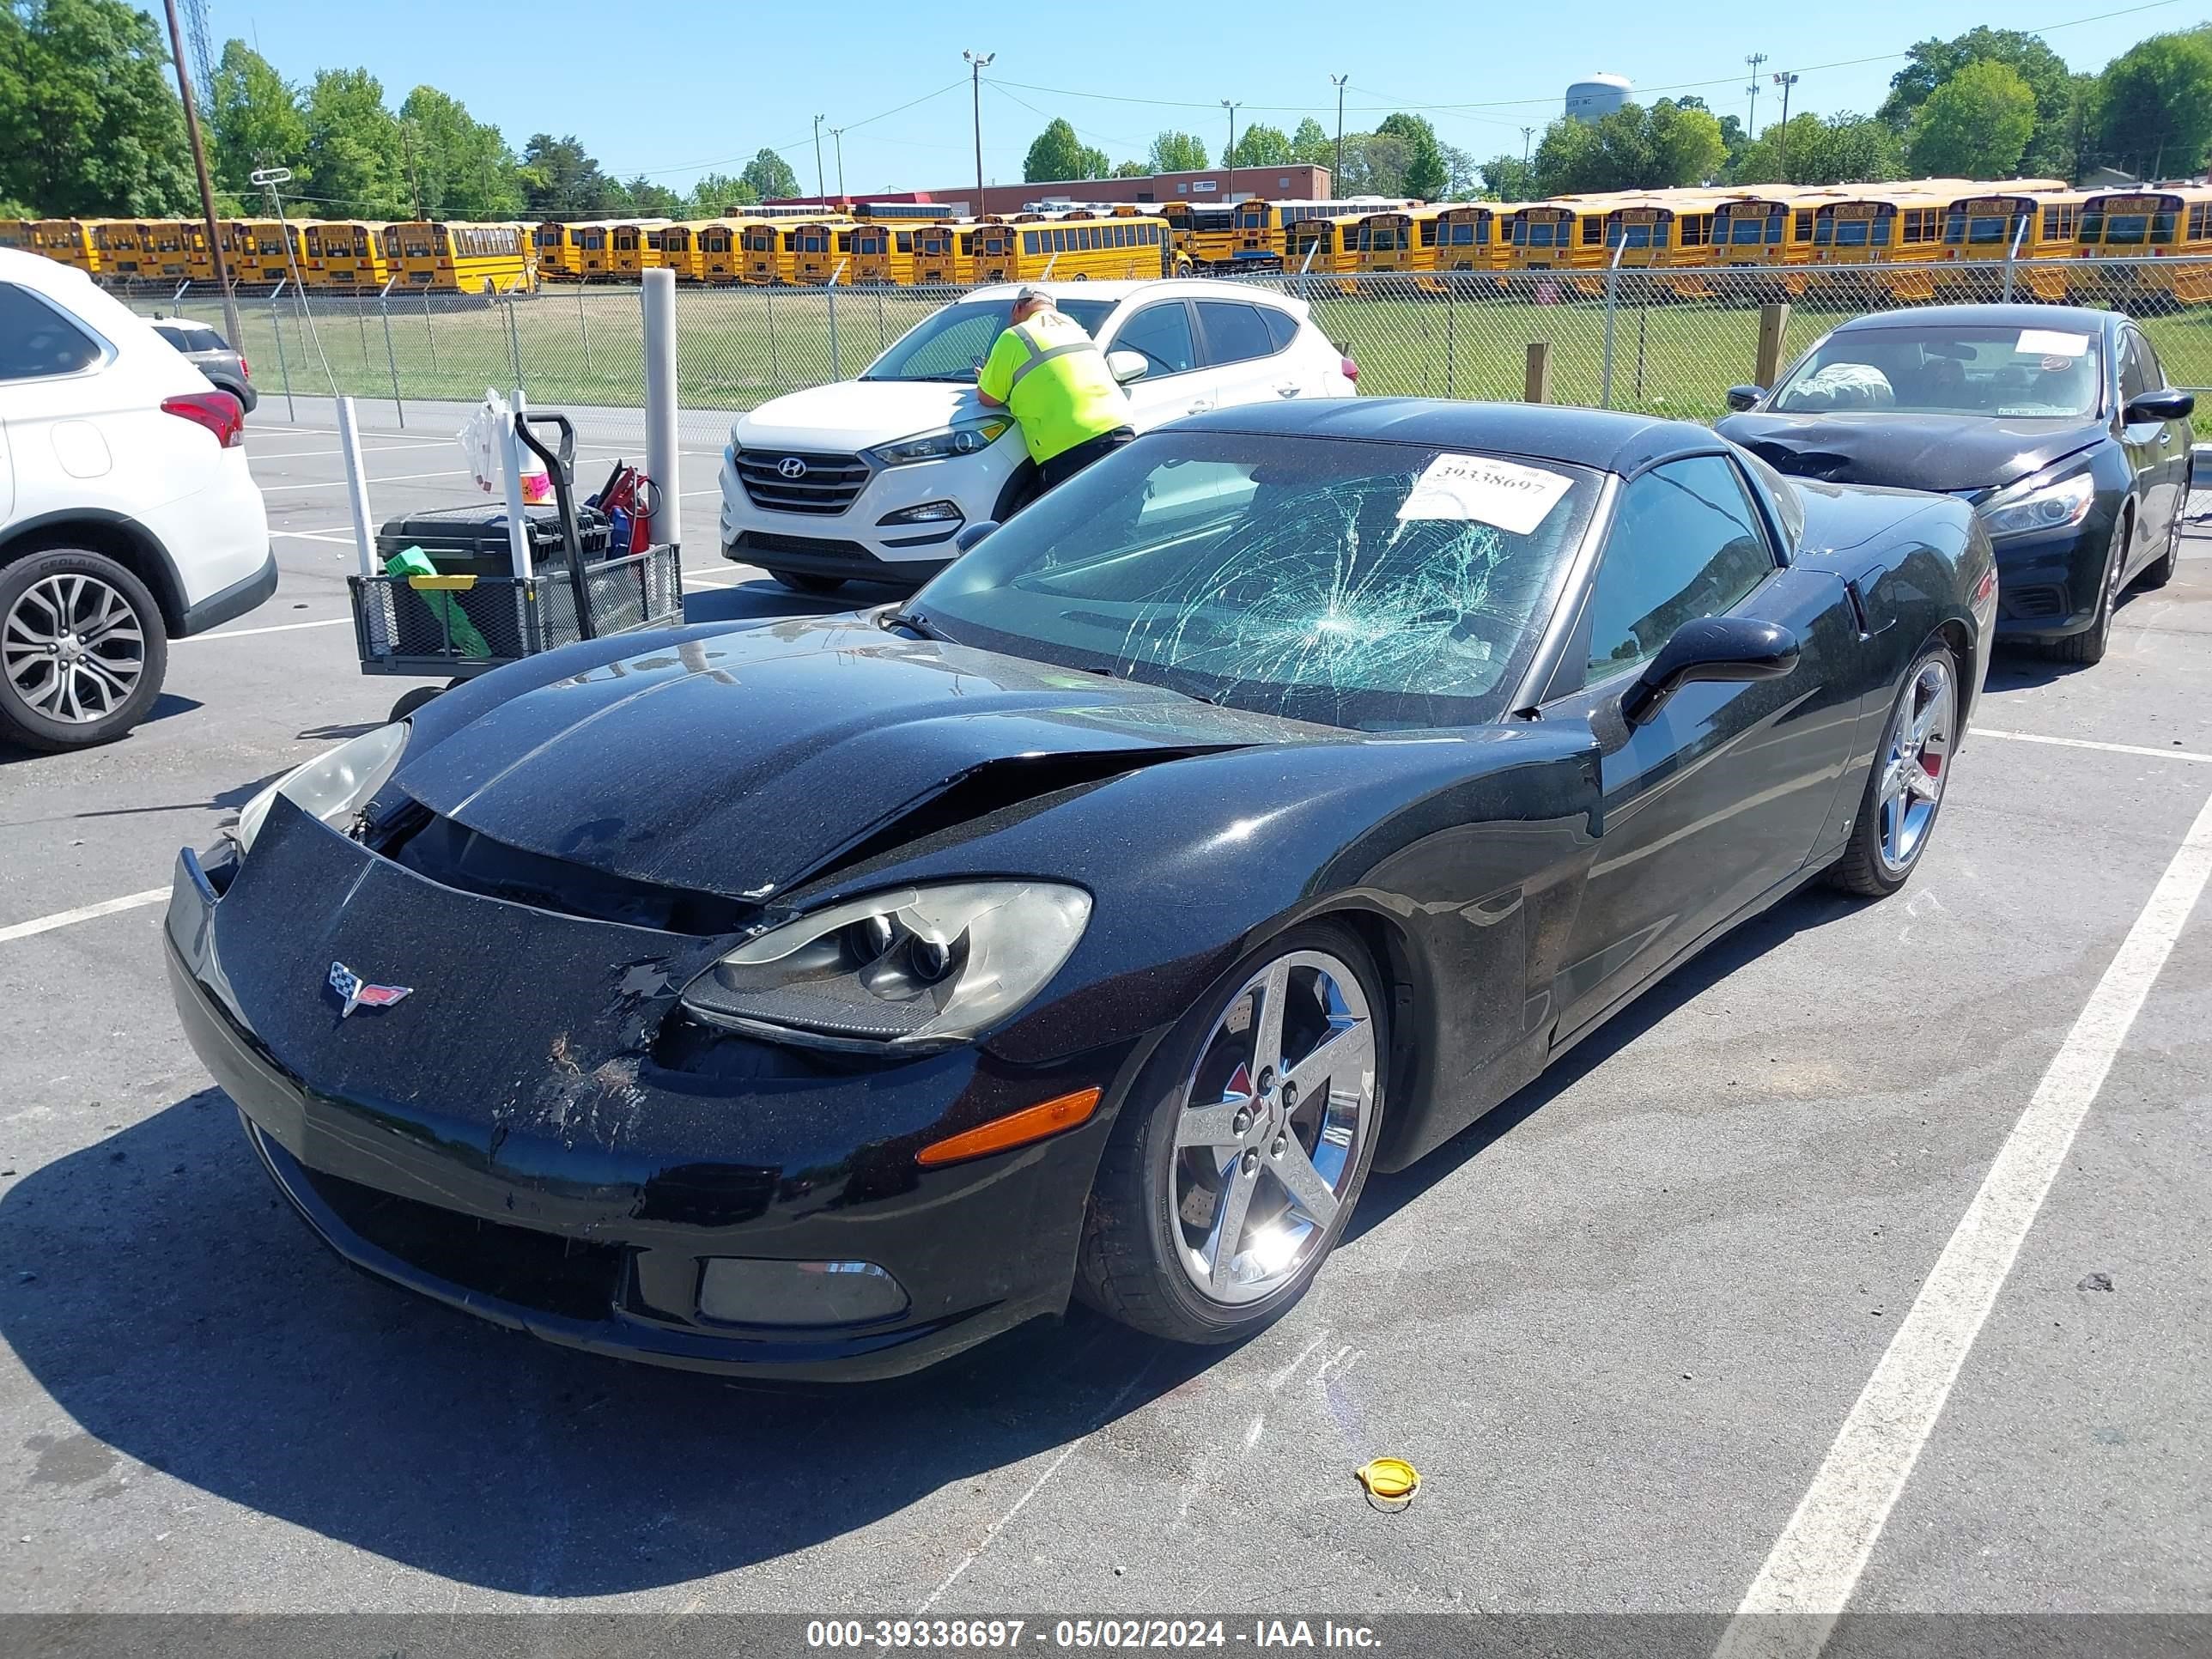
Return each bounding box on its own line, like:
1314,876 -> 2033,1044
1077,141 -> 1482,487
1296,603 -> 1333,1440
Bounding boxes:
1176,400 -> 1716,473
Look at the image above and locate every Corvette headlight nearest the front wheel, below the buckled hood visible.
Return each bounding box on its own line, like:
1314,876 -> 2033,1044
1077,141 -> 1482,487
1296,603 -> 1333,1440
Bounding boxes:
684,880 -> 1091,1048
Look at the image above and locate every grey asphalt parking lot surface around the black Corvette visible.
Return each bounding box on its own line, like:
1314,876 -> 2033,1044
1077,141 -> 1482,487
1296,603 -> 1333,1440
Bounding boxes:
0,400 -> 2212,1646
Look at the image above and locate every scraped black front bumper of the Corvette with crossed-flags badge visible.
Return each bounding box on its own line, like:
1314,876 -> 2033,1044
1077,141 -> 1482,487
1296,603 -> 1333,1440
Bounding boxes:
166,803 -> 1126,1380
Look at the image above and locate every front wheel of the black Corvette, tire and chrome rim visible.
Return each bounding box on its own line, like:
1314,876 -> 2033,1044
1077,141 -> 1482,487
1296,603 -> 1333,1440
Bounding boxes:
1078,922 -> 1389,1343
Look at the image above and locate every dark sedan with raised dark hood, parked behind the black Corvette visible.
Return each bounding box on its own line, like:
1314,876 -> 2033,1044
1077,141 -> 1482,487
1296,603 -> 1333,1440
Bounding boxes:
1721,305 -> 2197,664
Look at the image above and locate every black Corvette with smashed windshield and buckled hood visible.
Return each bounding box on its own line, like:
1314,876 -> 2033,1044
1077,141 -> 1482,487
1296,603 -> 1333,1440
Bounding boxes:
166,398 -> 1996,1376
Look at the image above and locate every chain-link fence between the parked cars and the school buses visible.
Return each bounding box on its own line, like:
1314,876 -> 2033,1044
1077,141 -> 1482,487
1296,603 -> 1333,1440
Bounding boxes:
131,258 -> 2212,435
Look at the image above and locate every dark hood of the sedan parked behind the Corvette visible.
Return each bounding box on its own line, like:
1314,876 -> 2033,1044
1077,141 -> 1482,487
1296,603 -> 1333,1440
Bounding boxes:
1721,411 -> 2104,495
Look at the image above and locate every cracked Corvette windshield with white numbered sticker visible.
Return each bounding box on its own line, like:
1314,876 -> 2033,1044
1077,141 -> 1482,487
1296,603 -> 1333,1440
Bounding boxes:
915,434 -> 1597,730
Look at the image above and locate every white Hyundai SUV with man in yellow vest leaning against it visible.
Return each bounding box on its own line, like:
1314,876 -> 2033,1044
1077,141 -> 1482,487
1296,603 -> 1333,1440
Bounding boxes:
721,281 -> 1358,592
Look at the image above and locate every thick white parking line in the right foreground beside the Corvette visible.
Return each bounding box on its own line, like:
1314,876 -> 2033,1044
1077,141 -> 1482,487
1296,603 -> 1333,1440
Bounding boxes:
1714,782 -> 2212,1659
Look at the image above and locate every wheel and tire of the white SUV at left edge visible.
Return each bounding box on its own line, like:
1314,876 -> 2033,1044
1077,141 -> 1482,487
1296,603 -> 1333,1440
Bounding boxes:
0,549 -> 168,750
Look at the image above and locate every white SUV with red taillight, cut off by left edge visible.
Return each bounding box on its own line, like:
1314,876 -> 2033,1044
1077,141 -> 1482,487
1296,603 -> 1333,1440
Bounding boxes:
0,248 -> 276,750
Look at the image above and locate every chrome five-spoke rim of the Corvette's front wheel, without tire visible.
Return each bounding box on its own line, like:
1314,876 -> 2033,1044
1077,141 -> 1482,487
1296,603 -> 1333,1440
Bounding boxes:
1172,951 -> 1376,1305
